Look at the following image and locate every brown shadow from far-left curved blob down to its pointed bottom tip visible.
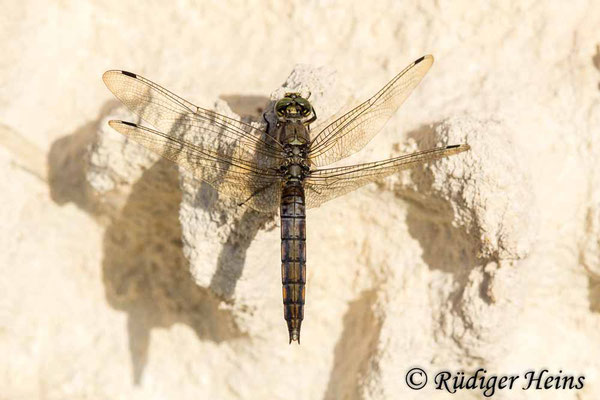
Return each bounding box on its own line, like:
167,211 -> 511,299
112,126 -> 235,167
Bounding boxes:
48,107 -> 244,384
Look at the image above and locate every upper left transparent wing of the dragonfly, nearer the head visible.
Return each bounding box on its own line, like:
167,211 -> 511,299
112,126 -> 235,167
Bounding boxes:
102,70 -> 283,168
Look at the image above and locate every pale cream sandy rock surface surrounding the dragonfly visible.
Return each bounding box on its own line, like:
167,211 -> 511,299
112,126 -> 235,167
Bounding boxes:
0,0 -> 600,399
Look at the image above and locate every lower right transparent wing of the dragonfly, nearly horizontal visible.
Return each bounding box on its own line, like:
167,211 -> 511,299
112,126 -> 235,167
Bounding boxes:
304,144 -> 470,208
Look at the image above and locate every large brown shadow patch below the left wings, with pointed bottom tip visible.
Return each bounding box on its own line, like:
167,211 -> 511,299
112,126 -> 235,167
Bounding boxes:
103,160 -> 242,383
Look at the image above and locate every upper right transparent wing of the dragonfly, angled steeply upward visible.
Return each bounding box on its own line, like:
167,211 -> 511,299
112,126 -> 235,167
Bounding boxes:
309,55 -> 433,166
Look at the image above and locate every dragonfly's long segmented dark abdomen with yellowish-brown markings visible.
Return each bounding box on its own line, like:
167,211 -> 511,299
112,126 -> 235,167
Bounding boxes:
281,180 -> 306,343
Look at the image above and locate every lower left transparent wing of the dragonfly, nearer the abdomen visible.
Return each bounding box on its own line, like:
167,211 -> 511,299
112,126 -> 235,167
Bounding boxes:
109,121 -> 281,212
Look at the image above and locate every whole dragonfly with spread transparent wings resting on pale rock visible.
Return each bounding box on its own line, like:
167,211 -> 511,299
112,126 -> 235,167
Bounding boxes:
102,55 -> 469,344
